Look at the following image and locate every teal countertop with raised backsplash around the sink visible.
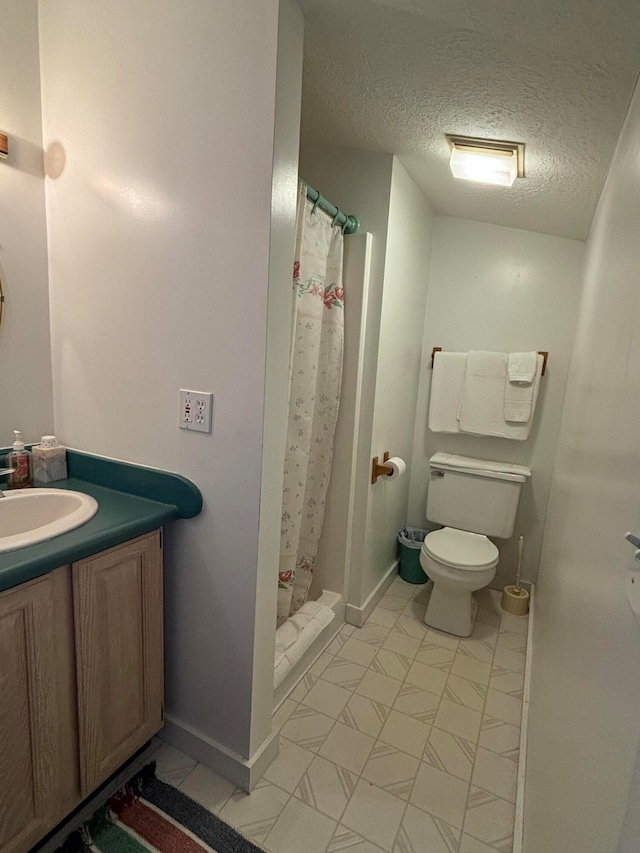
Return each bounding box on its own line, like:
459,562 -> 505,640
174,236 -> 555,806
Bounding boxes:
0,451 -> 202,591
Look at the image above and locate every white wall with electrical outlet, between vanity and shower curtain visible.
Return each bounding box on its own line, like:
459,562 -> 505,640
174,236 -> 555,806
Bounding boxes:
40,0 -> 288,768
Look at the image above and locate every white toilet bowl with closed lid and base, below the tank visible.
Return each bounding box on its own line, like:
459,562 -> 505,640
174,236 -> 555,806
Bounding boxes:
420,527 -> 498,637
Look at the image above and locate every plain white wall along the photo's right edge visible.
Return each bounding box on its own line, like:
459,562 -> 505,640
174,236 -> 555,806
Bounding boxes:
525,76 -> 640,853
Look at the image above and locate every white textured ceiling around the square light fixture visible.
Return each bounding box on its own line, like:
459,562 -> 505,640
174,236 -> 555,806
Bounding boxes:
298,0 -> 640,240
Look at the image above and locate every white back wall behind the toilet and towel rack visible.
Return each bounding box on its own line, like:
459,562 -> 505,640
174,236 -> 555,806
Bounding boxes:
410,217 -> 584,588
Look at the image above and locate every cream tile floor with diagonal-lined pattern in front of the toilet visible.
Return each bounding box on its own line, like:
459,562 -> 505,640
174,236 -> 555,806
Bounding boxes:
155,578 -> 527,853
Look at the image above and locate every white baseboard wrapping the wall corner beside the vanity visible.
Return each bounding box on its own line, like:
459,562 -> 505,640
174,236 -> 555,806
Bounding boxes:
162,715 -> 279,792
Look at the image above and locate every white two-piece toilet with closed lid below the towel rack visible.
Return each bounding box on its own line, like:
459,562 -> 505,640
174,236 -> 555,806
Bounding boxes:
420,453 -> 531,637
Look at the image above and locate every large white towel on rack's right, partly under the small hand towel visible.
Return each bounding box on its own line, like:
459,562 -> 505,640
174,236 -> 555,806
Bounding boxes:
459,351 -> 539,441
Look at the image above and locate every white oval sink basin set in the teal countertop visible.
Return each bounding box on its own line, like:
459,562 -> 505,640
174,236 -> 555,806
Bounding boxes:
0,489 -> 98,554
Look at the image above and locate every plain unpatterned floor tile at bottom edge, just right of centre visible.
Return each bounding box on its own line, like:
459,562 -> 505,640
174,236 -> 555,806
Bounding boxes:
342,779 -> 406,853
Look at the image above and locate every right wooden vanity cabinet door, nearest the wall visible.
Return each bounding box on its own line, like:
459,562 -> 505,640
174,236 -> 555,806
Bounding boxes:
73,531 -> 163,795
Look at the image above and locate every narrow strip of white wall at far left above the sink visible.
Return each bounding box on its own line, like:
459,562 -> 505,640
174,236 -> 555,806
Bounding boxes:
0,0 -> 53,446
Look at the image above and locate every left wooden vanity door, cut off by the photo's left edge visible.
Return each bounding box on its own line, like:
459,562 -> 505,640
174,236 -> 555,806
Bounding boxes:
0,575 -> 58,853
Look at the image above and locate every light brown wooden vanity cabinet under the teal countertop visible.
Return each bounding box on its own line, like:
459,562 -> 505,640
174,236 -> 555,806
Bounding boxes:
0,530 -> 163,853
